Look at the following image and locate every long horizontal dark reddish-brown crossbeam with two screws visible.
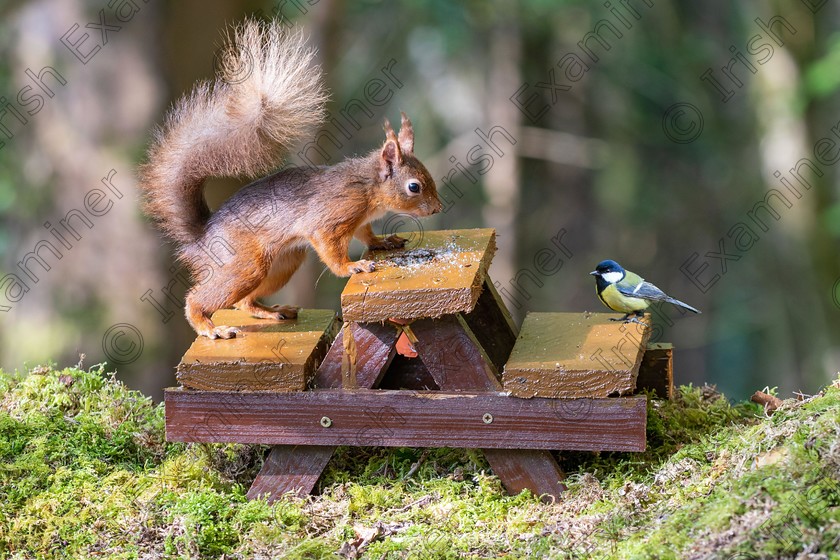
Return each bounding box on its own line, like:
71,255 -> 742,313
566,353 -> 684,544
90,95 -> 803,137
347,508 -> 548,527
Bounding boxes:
165,388 -> 646,452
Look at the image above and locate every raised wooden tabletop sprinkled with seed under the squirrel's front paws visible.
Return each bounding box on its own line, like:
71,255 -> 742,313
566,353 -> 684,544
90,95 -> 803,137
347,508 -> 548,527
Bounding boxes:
341,229 -> 496,322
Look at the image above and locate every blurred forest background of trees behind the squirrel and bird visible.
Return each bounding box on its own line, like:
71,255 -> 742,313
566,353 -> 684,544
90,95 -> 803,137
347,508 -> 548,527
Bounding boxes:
0,0 -> 840,399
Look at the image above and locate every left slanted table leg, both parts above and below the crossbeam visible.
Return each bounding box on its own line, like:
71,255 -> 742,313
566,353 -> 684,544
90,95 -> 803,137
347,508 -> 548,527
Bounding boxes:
248,323 -> 397,502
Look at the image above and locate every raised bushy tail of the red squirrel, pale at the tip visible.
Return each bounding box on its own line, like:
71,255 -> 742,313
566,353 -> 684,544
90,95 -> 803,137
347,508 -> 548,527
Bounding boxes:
140,20 -> 327,244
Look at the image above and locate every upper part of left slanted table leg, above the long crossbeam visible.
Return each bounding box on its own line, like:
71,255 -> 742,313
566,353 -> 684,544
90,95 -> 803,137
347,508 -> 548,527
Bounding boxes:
312,323 -> 399,389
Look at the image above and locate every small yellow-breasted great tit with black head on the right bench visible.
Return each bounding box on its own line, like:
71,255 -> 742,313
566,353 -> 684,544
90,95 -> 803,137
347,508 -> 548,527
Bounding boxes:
589,260 -> 700,323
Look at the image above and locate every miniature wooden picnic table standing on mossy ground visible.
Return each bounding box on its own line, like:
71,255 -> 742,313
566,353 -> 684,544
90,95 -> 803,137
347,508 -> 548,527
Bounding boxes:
165,229 -> 671,500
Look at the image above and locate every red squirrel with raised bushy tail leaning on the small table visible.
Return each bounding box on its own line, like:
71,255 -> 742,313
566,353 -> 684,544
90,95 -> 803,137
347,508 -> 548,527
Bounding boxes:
140,21 -> 442,338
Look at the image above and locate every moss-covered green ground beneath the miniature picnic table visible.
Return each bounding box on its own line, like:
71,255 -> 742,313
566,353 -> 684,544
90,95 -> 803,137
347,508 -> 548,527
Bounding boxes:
0,367 -> 840,559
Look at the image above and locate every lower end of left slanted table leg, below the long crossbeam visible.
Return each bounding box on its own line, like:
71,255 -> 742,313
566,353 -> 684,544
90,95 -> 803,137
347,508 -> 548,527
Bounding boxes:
247,445 -> 335,502
